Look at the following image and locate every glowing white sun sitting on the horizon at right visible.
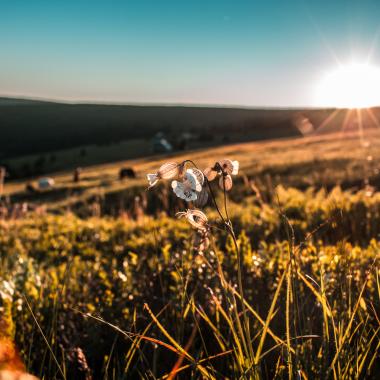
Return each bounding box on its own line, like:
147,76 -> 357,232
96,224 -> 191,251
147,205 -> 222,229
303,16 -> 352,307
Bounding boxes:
316,63 -> 380,108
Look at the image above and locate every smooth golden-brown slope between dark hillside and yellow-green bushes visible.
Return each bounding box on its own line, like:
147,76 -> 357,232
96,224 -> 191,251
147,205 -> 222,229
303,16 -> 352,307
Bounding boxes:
4,129 -> 380,211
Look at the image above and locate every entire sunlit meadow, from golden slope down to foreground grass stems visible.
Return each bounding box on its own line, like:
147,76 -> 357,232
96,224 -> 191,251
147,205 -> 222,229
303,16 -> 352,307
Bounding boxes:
0,130 -> 380,380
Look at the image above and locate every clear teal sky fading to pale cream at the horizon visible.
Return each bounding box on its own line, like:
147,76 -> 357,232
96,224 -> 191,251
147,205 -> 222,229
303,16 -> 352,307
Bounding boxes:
0,0 -> 380,107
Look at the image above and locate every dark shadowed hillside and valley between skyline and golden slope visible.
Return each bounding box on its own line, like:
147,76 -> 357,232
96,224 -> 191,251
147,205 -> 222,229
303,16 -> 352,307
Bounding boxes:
0,97 -> 380,180
